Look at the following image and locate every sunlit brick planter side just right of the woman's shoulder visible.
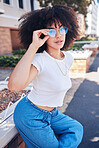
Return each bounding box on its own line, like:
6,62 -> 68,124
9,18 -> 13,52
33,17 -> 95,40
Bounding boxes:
70,57 -> 90,73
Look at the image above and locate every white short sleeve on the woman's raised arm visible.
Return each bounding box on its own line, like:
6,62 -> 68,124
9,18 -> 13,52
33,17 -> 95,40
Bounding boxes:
32,53 -> 43,73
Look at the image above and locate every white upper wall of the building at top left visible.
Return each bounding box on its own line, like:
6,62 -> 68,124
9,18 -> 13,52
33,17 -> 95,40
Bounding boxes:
0,0 -> 41,28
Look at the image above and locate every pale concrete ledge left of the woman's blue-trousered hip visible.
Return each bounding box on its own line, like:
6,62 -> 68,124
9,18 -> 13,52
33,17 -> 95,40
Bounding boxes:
0,100 -> 20,148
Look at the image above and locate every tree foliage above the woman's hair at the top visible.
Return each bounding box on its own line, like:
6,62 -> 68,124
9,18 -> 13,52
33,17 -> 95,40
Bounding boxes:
38,0 -> 94,16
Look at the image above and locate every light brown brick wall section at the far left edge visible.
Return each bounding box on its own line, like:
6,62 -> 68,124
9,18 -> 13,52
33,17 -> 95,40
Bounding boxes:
0,27 -> 12,55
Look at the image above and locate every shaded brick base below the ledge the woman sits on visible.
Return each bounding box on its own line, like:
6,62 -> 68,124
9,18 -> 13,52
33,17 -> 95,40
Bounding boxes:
4,133 -> 27,148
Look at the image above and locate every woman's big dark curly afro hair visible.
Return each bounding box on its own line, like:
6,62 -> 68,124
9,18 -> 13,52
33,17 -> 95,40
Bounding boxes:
19,5 -> 80,52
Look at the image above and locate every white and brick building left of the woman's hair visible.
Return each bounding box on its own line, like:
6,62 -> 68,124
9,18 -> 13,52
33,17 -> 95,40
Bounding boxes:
0,0 -> 40,54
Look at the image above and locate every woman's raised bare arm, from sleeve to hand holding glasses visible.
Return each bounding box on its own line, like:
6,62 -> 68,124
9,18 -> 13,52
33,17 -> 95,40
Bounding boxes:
8,29 -> 49,92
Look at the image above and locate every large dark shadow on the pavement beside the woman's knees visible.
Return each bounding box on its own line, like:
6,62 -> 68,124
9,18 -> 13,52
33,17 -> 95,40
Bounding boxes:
64,79 -> 99,148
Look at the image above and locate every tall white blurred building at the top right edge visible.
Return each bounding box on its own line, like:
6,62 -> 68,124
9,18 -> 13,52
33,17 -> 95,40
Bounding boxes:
86,1 -> 98,36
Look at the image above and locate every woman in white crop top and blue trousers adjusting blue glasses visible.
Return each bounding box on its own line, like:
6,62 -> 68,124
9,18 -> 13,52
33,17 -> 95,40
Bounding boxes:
8,5 -> 83,148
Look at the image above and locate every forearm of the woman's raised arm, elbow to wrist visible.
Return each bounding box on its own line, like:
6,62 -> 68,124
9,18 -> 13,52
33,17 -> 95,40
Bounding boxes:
8,44 -> 37,91
